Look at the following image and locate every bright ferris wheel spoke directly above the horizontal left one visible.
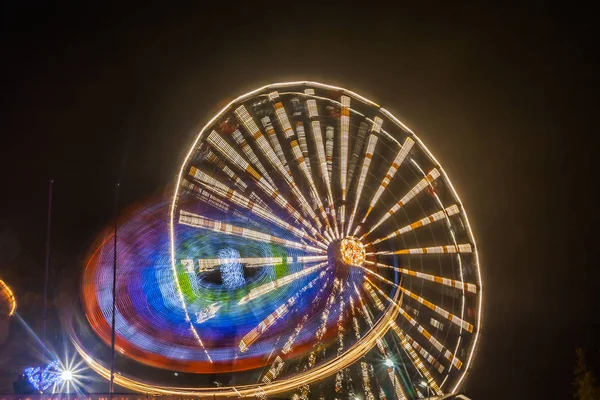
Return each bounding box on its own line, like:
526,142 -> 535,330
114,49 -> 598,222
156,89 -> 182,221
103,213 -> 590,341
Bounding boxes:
179,210 -> 325,254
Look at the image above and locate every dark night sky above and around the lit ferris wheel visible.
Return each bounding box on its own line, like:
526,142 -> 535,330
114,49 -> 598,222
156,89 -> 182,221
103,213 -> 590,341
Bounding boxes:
0,1 -> 600,399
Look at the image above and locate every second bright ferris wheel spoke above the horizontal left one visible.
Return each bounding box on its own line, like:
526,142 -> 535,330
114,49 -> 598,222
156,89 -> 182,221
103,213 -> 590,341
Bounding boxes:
190,167 -> 327,249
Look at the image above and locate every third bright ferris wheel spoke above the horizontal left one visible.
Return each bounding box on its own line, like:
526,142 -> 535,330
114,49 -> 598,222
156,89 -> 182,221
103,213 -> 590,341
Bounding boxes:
206,130 -> 324,239
